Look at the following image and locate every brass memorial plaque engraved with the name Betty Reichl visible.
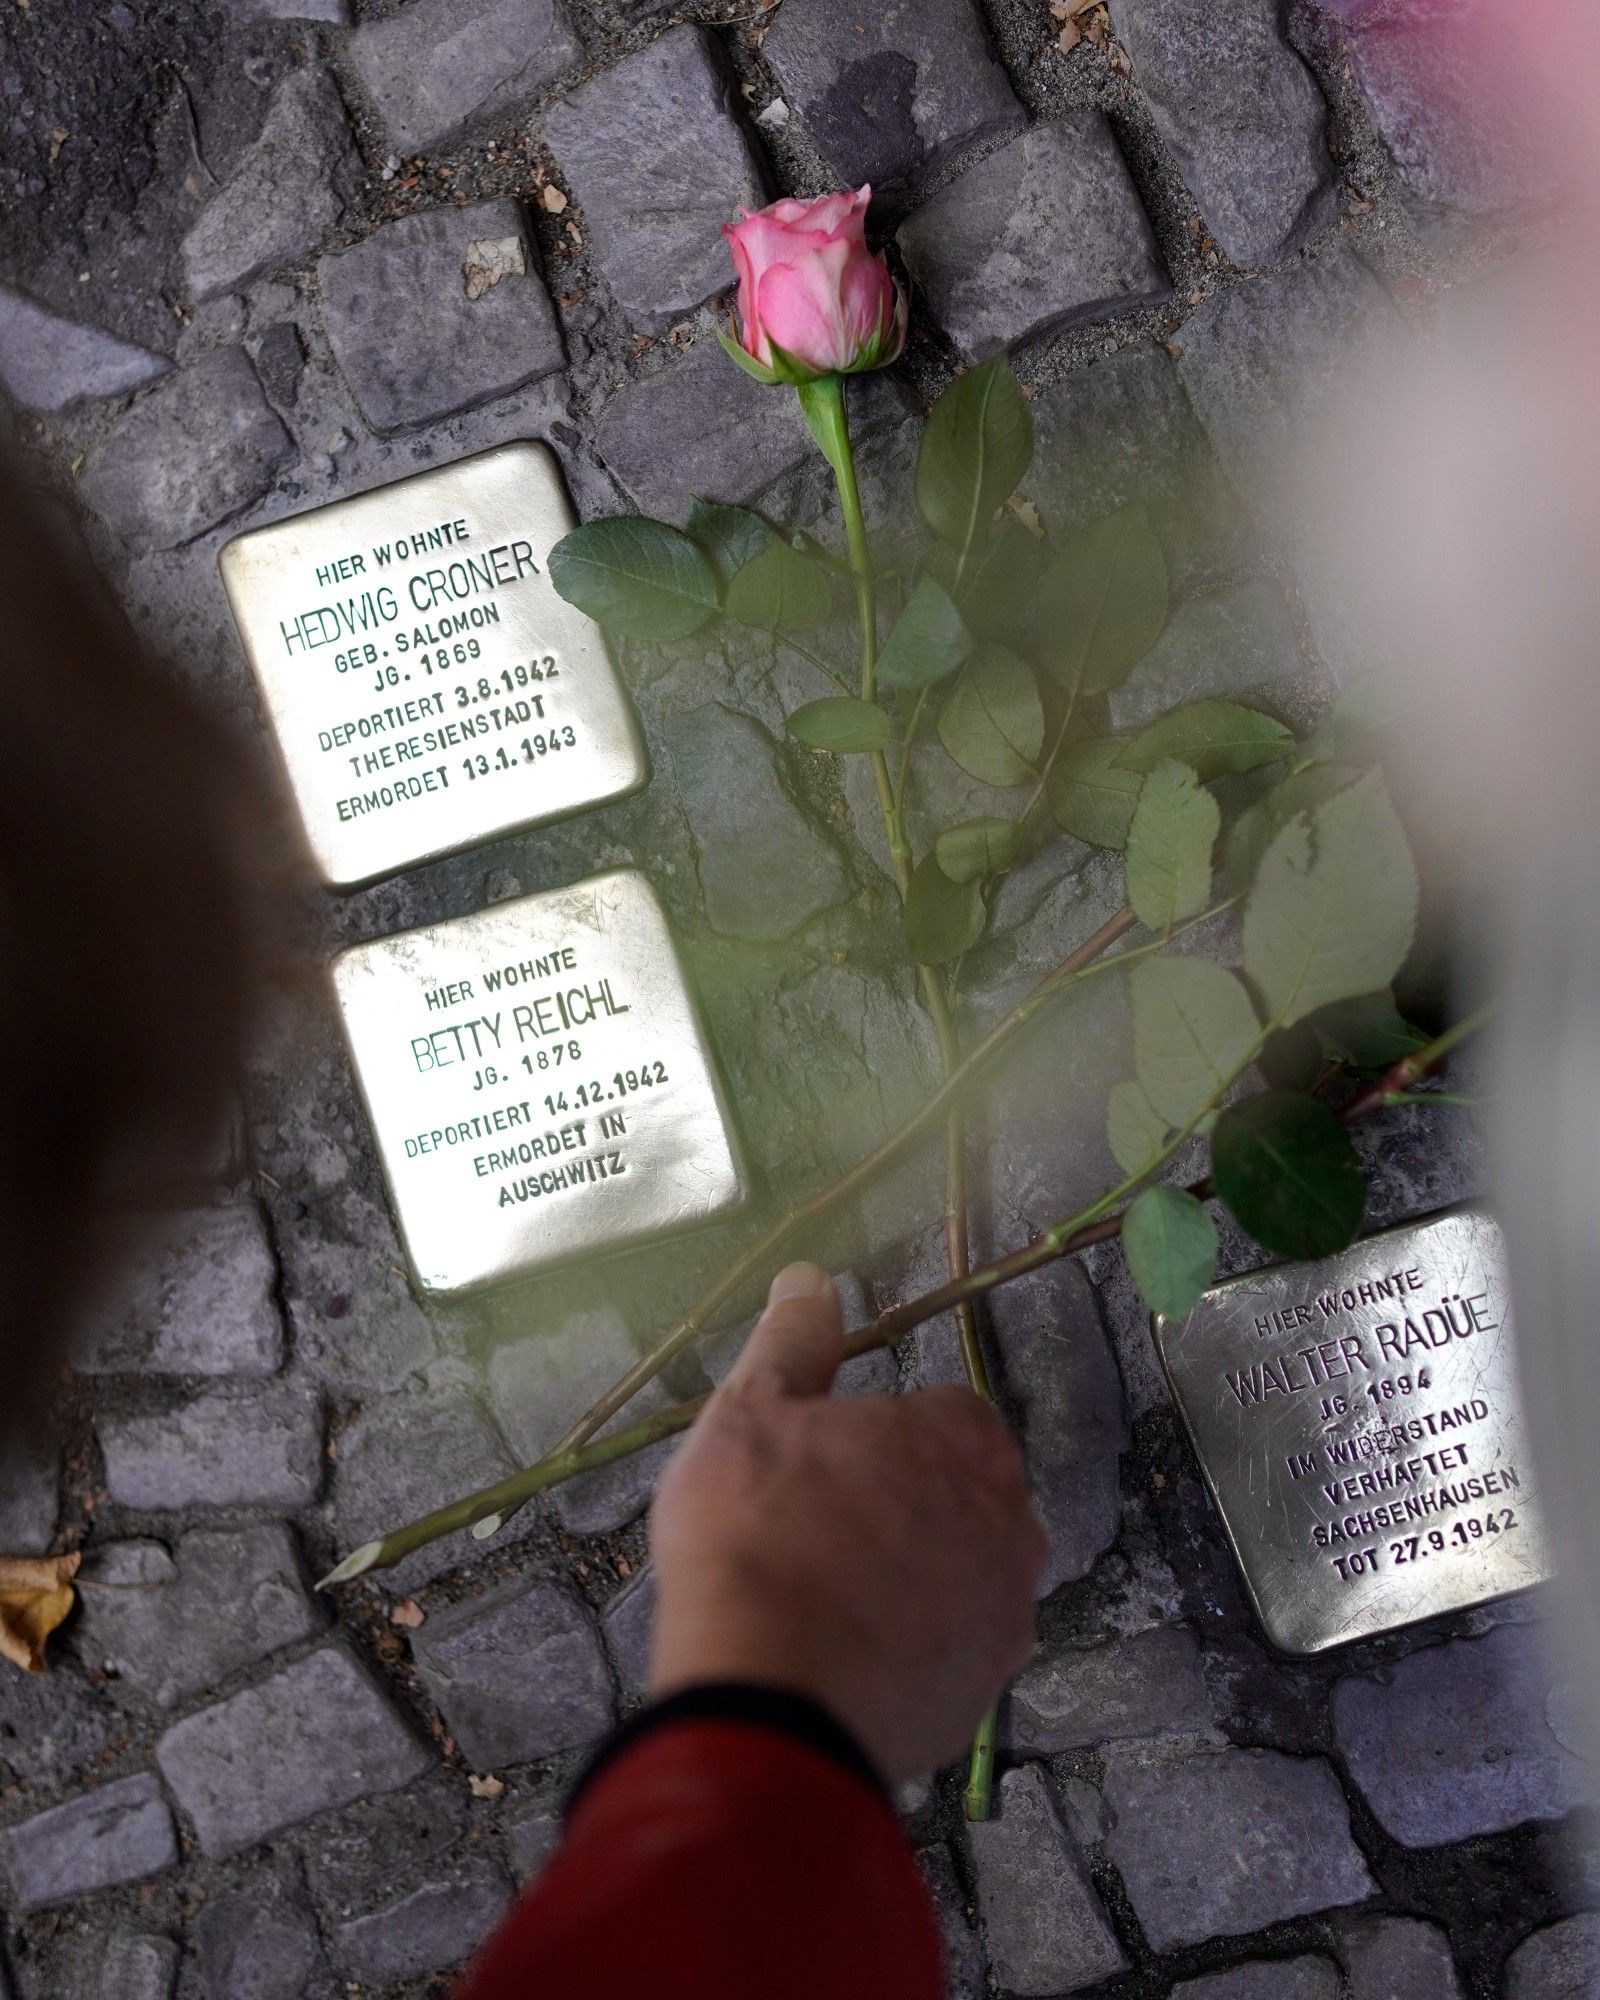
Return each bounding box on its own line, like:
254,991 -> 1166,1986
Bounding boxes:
332,868 -> 744,1292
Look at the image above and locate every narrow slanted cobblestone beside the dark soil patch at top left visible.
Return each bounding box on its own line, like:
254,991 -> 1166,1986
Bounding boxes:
184,68 -> 362,298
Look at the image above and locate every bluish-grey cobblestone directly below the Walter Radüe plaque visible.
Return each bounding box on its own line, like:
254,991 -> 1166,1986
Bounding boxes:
1332,1626 -> 1598,1848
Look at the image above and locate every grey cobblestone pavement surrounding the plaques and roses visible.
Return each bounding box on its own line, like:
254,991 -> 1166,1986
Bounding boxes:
0,0 -> 1600,2000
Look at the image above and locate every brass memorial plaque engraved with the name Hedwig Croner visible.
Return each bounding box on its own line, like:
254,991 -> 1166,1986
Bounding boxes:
222,444 -> 648,888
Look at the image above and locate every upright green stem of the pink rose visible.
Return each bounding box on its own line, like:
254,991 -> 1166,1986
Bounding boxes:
798,376 -> 996,1820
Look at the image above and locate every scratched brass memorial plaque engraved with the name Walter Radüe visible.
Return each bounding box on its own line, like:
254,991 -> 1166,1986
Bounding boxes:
1154,1208 -> 1550,1654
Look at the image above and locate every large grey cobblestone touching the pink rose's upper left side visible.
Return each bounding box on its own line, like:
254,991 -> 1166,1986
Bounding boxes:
540,28 -> 766,326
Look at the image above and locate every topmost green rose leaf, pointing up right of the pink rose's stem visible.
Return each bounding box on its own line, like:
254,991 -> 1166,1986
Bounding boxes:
916,354 -> 1034,564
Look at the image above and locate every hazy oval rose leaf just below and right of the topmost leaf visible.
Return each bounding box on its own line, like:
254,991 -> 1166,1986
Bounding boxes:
1034,506 -> 1168,694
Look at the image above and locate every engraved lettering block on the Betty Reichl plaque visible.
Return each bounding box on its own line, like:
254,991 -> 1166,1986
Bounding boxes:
406,944 -> 636,1208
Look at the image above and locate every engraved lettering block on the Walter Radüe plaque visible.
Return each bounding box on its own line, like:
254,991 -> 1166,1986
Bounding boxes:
1226,1264 -> 1522,1574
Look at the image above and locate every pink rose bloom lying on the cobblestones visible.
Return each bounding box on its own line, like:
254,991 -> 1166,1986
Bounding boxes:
722,188 -> 906,382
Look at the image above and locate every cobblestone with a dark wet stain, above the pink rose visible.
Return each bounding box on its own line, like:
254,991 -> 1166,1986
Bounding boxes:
762,0 -> 1026,194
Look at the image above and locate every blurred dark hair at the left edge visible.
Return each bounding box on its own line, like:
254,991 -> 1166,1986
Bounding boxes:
0,454 -> 278,1422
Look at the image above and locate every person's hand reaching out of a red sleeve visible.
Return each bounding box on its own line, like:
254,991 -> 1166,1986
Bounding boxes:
650,1264 -> 1048,1784
